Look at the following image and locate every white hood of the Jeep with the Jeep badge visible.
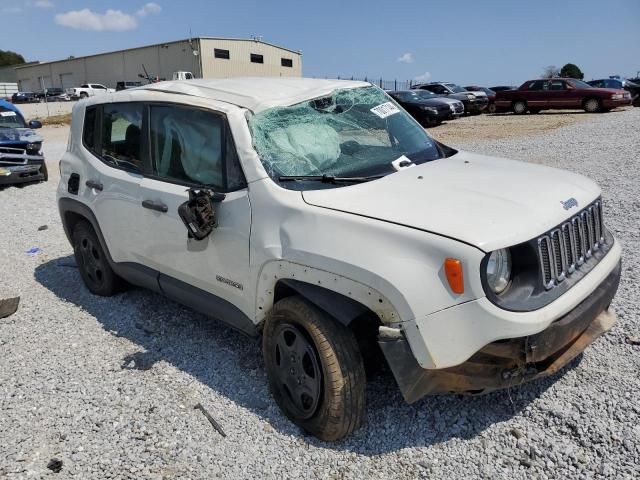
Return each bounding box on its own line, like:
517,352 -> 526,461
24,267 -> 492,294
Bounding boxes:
302,152 -> 600,252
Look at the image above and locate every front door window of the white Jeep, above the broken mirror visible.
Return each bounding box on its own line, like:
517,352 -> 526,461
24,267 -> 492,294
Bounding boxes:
149,105 -> 244,191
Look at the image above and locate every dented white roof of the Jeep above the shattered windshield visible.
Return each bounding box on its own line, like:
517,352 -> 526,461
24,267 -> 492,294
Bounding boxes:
138,77 -> 371,113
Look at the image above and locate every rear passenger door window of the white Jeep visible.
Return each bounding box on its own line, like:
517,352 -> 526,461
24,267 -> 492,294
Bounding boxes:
101,103 -> 143,171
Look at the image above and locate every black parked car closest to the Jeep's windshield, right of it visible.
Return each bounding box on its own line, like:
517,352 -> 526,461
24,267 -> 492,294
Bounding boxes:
387,90 -> 464,127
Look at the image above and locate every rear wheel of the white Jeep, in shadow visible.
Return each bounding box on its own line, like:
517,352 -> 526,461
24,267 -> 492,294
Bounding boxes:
73,220 -> 124,297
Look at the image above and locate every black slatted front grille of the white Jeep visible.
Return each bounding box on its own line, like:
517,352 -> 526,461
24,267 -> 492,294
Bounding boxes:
538,200 -> 606,290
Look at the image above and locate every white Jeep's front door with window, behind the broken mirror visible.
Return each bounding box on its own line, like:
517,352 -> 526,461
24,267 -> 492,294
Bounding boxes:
139,104 -> 253,323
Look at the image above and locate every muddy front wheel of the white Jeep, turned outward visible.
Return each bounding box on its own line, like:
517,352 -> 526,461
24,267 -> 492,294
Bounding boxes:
262,296 -> 366,441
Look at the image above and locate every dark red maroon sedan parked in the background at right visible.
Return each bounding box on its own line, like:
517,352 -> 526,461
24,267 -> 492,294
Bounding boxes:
496,78 -> 631,114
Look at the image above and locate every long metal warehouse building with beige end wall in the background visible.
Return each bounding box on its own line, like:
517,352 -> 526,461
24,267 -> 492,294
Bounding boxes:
15,37 -> 302,92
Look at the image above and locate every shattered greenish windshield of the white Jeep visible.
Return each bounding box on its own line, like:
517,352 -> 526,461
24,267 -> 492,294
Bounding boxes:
249,87 -> 443,188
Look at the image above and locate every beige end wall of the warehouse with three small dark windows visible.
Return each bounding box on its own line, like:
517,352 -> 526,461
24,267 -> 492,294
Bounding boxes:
200,38 -> 302,78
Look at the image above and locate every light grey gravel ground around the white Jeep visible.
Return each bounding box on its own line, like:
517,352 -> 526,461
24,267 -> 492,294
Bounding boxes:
0,109 -> 640,479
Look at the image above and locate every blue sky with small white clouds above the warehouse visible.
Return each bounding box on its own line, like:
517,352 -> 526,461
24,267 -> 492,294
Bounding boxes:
0,0 -> 640,85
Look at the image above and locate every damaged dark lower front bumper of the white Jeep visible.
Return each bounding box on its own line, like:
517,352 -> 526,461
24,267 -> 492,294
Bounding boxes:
378,263 -> 620,403
